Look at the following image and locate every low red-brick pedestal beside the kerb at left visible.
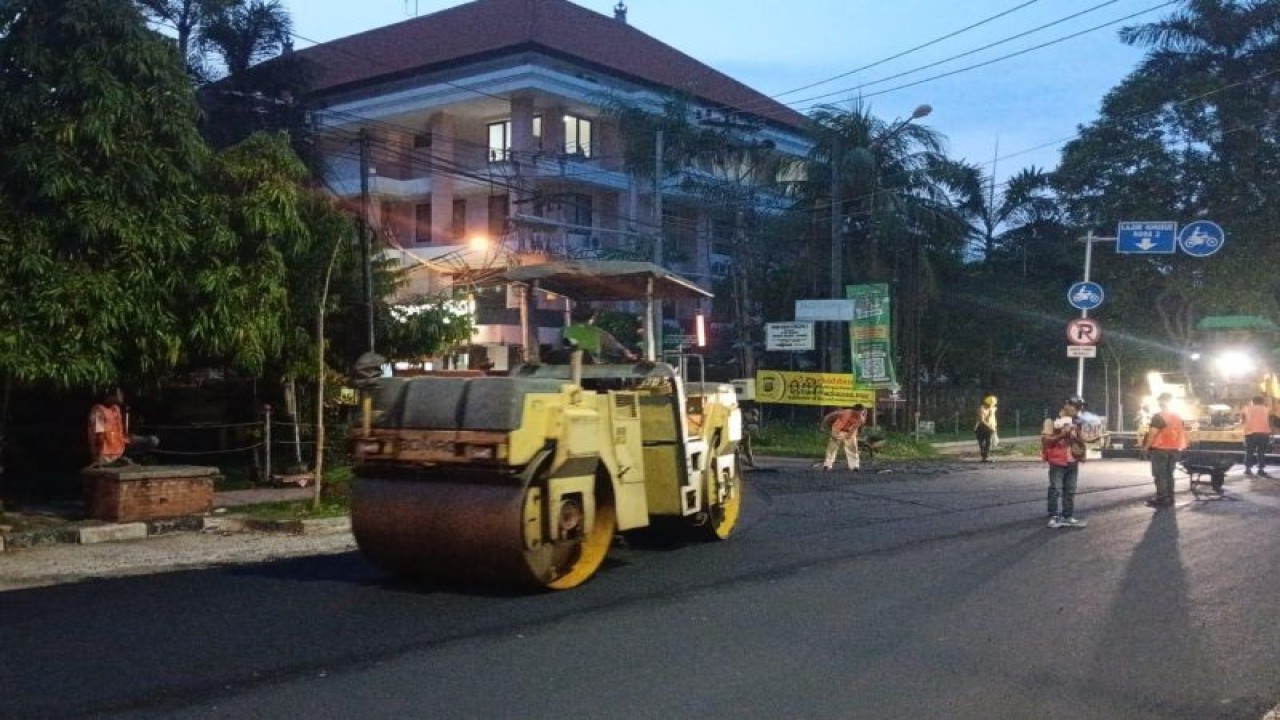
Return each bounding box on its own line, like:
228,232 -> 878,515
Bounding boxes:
83,465 -> 218,523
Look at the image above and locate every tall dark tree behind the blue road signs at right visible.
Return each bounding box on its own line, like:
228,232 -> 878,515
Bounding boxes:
1056,0 -> 1280,346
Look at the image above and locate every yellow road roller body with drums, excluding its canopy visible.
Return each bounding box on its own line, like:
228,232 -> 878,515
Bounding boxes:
351,352 -> 742,591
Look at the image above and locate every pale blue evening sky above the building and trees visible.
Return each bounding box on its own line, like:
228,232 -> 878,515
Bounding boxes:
284,0 -> 1178,181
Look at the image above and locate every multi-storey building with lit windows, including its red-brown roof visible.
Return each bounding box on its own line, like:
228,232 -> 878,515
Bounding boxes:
296,0 -> 809,370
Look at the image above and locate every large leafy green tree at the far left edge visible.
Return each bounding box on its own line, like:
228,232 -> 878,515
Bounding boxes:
0,0 -> 216,386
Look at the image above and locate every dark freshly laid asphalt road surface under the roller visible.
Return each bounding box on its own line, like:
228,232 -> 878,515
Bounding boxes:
0,460 -> 1280,720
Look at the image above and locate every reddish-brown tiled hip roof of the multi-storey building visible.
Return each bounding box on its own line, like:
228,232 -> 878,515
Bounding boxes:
296,0 -> 806,128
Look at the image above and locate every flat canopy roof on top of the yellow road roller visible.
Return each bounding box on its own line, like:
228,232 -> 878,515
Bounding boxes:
503,260 -> 713,301
